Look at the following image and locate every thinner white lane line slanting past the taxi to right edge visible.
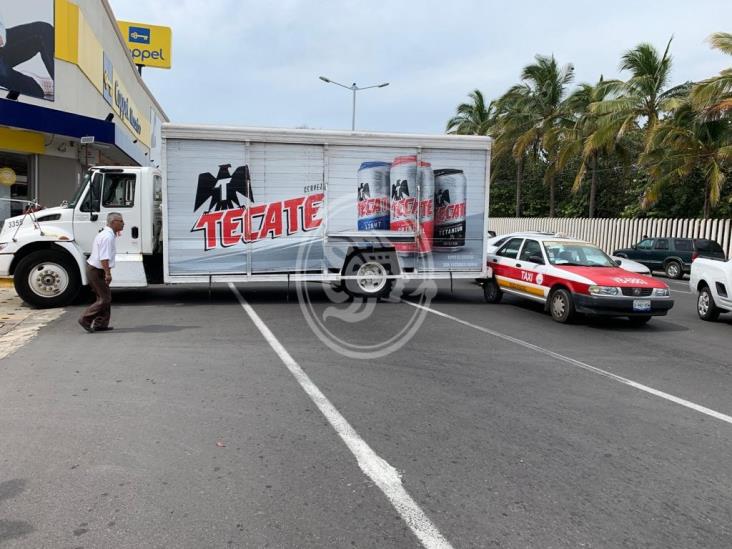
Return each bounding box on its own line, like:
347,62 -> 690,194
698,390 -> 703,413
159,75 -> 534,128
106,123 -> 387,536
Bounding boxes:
402,300 -> 732,424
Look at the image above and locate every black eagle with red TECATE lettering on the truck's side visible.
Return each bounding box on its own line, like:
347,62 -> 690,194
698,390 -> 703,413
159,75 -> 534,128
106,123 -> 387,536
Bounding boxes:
191,164 -> 325,251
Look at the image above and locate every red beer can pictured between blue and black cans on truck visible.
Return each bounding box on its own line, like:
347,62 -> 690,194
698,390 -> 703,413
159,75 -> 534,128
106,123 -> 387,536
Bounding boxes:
389,155 -> 434,253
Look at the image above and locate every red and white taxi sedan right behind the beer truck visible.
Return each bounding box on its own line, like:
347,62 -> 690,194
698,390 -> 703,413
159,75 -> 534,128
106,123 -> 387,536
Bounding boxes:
483,235 -> 674,324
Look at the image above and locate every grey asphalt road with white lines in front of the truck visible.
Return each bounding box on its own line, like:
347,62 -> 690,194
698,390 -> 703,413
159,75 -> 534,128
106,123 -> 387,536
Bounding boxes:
0,281 -> 732,548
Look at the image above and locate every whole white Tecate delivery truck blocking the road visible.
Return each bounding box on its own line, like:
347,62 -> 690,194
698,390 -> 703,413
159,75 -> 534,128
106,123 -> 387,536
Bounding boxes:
0,124 -> 491,307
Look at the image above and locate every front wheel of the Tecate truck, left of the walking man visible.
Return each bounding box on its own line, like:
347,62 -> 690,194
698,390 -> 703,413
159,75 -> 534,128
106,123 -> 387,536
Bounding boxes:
13,250 -> 81,309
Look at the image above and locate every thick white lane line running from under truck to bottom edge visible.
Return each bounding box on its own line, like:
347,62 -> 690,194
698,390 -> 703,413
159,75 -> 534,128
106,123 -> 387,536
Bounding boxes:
229,282 -> 452,549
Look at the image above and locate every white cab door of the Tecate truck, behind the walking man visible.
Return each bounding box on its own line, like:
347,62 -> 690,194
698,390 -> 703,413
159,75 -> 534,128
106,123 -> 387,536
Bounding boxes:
74,169 -> 144,254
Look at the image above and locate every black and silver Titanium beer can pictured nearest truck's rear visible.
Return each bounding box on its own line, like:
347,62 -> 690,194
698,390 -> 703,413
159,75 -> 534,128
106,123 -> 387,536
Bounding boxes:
433,169 -> 467,252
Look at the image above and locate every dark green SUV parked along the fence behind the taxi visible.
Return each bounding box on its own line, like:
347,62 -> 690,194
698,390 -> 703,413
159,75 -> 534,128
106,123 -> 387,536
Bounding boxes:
613,237 -> 725,278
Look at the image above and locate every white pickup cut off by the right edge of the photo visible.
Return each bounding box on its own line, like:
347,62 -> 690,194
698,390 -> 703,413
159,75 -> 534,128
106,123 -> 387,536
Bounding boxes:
689,257 -> 732,320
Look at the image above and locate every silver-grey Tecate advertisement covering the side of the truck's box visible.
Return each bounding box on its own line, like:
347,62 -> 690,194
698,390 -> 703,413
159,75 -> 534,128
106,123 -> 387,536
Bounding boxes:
166,139 -> 486,275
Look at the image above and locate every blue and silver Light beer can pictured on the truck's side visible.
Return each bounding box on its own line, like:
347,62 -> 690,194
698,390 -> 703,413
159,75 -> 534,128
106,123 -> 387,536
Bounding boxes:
356,162 -> 391,231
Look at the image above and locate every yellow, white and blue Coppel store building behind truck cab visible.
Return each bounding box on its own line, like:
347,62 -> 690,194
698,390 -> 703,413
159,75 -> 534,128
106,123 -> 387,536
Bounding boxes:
0,0 -> 168,221
